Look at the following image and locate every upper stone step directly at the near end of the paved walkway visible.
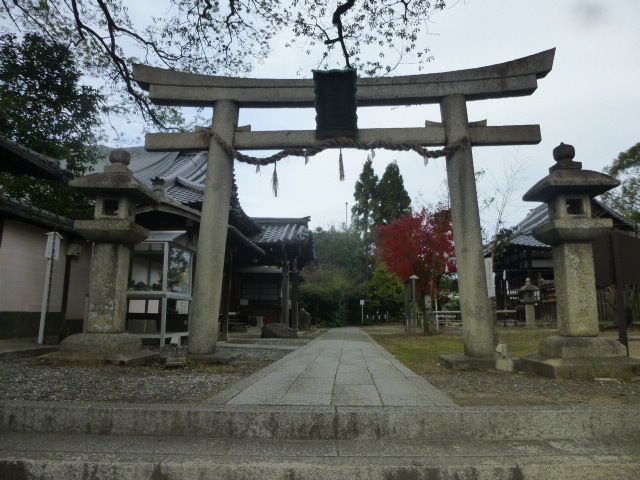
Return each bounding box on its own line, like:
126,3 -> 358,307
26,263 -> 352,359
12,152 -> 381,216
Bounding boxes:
0,401 -> 640,440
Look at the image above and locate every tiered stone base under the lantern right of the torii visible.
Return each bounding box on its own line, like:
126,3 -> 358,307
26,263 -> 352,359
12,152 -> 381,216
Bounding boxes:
520,337 -> 640,380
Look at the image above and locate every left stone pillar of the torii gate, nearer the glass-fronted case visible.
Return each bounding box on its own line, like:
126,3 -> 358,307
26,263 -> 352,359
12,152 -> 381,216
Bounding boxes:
188,100 -> 239,355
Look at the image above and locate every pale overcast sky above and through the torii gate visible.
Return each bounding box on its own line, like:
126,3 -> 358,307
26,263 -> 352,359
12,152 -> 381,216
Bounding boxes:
122,0 -> 640,231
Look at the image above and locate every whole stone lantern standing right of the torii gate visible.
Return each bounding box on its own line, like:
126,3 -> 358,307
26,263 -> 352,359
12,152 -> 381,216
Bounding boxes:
522,143 -> 640,379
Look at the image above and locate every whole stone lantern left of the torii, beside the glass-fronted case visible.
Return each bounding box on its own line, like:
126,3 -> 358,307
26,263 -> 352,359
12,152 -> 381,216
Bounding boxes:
48,149 -> 158,365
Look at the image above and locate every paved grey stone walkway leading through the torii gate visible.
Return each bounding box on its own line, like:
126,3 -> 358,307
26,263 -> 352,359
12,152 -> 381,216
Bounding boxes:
209,328 -> 455,407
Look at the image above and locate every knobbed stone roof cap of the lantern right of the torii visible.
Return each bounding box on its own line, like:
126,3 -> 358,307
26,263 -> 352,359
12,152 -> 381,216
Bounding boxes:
522,143 -> 620,203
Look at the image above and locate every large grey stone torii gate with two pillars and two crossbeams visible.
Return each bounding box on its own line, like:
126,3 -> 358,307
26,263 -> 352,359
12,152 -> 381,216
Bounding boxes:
134,49 -> 555,357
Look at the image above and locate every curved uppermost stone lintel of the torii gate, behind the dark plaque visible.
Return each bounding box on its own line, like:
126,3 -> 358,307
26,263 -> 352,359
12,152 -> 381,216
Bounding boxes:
133,48 -> 555,108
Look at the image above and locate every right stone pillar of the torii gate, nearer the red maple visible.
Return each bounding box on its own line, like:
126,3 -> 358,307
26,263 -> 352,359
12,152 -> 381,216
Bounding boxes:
440,94 -> 494,357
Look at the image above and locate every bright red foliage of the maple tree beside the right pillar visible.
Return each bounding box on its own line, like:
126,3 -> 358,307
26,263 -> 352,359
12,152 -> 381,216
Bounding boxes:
376,206 -> 456,298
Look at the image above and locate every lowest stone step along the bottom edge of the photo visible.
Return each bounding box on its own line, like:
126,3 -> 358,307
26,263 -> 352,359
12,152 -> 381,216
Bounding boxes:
0,434 -> 640,480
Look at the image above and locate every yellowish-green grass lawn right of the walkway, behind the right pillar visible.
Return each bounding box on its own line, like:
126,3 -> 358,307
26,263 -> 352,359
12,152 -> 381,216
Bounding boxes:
364,326 -> 557,374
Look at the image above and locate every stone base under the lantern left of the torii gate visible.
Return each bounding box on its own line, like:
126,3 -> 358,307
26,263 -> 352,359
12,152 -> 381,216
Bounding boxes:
40,333 -> 159,365
